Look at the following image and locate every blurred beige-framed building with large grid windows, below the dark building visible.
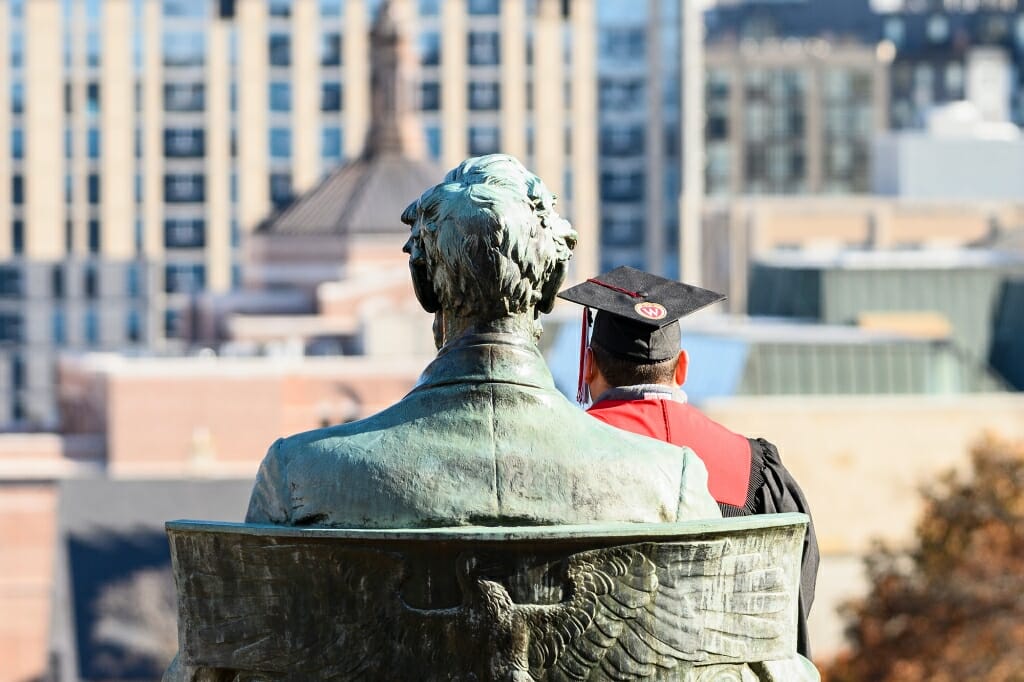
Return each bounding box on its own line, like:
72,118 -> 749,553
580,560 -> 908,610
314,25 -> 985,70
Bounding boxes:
705,39 -> 892,197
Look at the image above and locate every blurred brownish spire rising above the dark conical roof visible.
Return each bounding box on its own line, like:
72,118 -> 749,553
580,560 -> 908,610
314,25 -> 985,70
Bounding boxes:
362,0 -> 426,159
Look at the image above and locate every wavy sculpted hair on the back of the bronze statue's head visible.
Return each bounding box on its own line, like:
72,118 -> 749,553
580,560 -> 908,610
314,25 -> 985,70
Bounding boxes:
401,154 -> 577,319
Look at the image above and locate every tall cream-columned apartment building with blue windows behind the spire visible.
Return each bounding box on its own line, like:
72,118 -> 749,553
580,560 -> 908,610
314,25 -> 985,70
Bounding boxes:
0,0 -> 702,428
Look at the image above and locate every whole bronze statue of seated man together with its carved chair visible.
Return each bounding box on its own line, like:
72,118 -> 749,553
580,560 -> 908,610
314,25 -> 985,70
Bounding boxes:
164,155 -> 818,682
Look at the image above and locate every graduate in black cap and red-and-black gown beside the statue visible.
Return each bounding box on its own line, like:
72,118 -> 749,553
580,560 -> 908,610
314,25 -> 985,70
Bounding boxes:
559,266 -> 818,658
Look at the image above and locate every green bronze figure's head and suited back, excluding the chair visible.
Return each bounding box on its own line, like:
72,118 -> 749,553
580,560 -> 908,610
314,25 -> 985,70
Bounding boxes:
246,155 -> 719,528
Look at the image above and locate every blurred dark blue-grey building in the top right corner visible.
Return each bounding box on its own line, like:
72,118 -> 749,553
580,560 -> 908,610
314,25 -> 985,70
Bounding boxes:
708,0 -> 1024,129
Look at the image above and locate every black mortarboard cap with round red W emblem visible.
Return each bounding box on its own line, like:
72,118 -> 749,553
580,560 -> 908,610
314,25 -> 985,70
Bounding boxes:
558,266 -> 725,363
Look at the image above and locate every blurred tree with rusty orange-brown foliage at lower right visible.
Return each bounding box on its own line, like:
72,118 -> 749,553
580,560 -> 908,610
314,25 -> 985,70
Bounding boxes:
822,438 -> 1024,682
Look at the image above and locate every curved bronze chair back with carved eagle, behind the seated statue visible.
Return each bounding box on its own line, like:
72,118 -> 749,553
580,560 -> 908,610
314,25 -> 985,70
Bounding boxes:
167,514 -> 818,682
